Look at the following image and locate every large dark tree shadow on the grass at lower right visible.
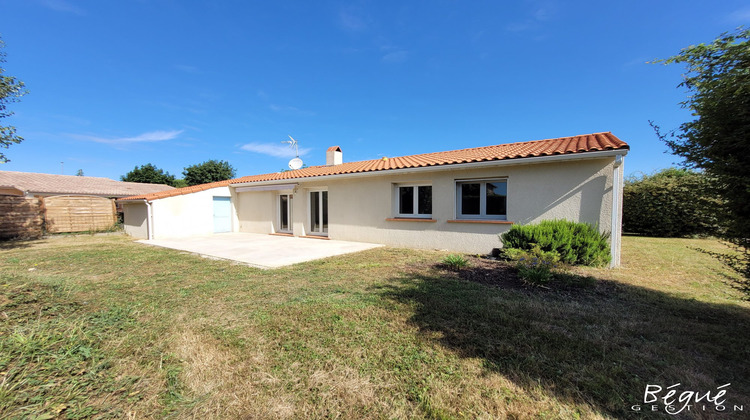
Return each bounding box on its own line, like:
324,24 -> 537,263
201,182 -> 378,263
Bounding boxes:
378,265 -> 750,418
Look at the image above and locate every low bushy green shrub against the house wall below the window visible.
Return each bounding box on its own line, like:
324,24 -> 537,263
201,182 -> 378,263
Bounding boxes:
500,220 -> 610,265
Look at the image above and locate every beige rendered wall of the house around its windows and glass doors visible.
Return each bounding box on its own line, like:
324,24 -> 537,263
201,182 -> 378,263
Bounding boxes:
239,157 -> 619,253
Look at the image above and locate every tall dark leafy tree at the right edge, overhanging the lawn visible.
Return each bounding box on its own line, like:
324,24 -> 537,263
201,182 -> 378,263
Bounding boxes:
652,29 -> 750,295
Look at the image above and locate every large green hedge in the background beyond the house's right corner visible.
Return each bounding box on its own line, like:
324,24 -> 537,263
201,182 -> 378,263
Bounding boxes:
622,168 -> 721,237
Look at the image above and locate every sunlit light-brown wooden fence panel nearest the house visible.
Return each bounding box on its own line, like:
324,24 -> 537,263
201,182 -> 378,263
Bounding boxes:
44,195 -> 117,233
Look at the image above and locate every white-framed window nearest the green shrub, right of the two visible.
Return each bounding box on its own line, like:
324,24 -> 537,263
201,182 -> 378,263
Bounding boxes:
456,178 -> 508,220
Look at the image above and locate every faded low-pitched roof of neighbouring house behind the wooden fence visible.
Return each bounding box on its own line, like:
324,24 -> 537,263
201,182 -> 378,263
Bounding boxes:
0,171 -> 174,197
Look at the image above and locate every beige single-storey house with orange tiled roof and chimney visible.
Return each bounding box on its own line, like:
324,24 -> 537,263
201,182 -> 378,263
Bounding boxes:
120,132 -> 629,265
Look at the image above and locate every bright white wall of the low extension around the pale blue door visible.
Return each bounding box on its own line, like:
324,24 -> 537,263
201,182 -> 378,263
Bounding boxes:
151,187 -> 238,239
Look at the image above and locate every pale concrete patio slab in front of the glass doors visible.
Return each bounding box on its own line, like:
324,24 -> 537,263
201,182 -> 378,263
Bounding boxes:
138,233 -> 383,269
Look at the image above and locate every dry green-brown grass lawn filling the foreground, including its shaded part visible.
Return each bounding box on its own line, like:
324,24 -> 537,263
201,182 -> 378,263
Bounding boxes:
0,236 -> 750,419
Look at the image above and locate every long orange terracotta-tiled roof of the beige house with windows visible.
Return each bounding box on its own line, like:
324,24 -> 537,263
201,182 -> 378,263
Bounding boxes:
121,132 -> 630,201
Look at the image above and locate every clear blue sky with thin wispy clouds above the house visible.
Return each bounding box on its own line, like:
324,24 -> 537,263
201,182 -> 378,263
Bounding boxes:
0,0 -> 750,179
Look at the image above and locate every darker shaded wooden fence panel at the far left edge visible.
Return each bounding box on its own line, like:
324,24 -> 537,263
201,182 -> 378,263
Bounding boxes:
0,196 -> 44,239
